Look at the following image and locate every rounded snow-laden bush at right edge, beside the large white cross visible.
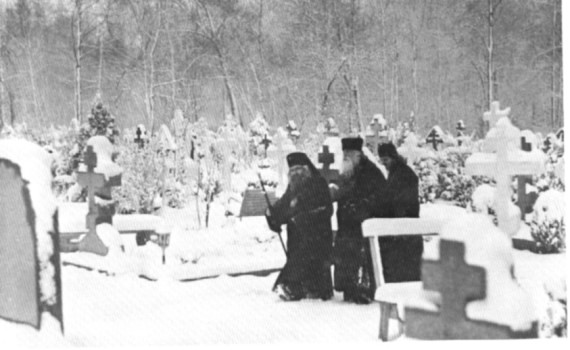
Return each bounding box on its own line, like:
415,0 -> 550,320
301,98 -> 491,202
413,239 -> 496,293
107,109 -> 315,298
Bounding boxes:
530,190 -> 566,253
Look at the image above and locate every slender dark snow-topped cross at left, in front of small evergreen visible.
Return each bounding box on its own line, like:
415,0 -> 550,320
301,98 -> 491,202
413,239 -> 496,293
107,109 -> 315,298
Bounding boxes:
77,146 -> 108,255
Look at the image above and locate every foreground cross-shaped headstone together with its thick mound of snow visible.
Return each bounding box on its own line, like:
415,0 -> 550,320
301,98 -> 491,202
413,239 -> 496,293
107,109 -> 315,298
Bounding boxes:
405,214 -> 538,340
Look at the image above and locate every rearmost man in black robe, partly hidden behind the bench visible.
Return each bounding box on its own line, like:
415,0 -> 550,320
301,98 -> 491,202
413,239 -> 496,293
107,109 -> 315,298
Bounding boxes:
378,143 -> 423,282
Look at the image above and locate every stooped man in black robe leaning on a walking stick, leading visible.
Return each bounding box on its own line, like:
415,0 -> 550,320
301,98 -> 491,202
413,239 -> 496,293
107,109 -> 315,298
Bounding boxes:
266,152 -> 333,301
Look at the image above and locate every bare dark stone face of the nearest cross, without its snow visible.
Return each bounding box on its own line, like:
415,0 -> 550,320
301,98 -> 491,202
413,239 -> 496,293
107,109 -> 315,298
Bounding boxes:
405,239 -> 512,340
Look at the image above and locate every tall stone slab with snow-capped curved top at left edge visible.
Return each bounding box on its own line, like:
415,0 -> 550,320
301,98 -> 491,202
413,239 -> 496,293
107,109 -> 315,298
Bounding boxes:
0,139 -> 63,331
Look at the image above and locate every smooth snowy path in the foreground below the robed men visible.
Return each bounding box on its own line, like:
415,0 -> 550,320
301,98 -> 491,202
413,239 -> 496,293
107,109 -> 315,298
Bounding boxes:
63,267 -> 379,346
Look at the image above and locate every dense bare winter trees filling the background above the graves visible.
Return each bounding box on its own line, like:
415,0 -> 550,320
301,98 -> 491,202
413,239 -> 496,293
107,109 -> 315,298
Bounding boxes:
0,0 -> 563,134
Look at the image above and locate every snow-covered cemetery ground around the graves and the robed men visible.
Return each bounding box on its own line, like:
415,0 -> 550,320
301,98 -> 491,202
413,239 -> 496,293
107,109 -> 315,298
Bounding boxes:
0,201 -> 567,346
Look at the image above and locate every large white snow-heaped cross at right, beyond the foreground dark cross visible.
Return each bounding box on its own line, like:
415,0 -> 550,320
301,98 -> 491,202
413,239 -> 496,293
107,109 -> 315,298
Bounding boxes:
465,117 -> 544,233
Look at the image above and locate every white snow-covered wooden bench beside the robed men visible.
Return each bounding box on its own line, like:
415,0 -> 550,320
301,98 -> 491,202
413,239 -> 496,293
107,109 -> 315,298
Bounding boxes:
362,218 -> 445,341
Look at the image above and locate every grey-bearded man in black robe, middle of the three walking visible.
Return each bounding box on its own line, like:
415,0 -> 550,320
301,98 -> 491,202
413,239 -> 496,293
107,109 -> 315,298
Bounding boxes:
331,138 -> 386,304
